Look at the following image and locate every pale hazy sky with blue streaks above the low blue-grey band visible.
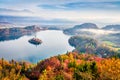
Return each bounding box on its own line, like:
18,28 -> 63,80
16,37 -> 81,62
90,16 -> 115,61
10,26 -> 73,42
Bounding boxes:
0,0 -> 120,24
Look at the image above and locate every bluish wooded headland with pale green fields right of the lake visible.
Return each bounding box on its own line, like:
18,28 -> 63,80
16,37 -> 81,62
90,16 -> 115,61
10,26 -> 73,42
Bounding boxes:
69,36 -> 120,58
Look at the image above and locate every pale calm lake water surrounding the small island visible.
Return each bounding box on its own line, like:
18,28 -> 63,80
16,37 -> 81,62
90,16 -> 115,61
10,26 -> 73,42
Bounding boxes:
0,30 -> 74,63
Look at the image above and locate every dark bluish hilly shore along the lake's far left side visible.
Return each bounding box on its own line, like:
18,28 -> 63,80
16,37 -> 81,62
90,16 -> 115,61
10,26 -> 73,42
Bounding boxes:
0,25 -> 41,41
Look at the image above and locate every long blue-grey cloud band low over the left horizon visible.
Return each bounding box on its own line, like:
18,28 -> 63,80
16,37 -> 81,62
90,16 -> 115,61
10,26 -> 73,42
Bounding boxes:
0,15 -> 74,24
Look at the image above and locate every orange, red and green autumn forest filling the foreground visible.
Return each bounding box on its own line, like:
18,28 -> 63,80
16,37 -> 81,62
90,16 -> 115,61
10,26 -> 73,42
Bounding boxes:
0,52 -> 120,80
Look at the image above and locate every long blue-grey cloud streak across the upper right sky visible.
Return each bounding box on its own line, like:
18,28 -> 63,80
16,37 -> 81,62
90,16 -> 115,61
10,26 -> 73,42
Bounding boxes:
38,1 -> 120,10
